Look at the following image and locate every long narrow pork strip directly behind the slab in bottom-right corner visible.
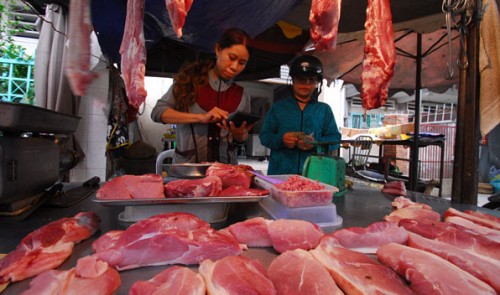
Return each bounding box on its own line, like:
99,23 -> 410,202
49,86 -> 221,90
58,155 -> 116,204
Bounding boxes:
408,233 -> 500,293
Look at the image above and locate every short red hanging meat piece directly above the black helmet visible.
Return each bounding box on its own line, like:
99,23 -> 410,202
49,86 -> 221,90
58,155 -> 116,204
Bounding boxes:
309,0 -> 342,51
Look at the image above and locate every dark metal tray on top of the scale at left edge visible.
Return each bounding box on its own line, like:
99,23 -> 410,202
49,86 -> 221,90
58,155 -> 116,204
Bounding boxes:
0,102 -> 81,134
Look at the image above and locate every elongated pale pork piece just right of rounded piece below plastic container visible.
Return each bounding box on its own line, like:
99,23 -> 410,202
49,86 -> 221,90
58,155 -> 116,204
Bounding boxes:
330,221 -> 408,253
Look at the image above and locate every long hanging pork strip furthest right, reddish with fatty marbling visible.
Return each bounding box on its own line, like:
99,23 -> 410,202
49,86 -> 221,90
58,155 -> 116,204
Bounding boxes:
361,0 -> 396,111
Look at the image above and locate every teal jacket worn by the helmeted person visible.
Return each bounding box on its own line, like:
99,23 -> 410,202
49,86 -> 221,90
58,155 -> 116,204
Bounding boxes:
259,95 -> 341,175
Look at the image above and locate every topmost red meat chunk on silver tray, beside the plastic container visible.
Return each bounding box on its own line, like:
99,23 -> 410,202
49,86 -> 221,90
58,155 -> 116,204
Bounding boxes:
206,162 -> 253,188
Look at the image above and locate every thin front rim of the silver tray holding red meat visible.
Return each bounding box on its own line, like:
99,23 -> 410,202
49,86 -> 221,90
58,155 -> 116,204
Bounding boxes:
92,195 -> 269,206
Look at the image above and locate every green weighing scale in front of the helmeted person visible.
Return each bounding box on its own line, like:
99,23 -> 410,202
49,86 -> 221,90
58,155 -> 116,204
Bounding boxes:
302,142 -> 347,197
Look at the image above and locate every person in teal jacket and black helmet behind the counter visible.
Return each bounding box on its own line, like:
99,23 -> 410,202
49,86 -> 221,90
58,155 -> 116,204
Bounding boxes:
259,55 -> 341,175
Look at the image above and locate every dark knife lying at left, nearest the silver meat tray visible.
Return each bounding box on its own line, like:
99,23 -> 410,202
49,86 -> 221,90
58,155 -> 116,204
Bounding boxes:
45,176 -> 101,208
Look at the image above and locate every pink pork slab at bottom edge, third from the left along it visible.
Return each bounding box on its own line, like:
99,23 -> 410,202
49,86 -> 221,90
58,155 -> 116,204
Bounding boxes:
198,256 -> 276,295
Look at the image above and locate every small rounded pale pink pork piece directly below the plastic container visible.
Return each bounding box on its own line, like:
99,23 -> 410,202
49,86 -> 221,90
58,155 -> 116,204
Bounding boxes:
267,219 -> 324,253
